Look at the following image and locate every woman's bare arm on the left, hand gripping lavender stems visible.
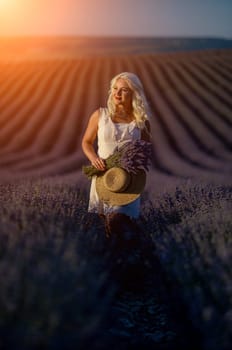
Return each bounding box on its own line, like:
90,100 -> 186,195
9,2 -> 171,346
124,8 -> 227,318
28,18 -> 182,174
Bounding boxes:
82,110 -> 105,170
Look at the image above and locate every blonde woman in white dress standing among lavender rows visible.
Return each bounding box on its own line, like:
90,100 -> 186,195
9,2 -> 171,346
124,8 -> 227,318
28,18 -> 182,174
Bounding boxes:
82,72 -> 150,238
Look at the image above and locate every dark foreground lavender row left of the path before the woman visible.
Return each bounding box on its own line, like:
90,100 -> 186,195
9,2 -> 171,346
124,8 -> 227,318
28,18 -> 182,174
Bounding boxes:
0,181 -> 113,349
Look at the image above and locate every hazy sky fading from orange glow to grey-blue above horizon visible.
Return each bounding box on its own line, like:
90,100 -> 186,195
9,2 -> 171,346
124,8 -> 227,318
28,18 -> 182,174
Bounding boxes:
0,0 -> 232,39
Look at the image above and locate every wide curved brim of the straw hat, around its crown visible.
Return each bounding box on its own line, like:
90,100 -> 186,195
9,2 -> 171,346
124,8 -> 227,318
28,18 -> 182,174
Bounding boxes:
96,170 -> 146,206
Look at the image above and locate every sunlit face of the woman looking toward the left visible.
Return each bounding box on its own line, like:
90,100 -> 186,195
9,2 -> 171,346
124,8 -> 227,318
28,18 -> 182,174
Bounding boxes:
112,78 -> 133,108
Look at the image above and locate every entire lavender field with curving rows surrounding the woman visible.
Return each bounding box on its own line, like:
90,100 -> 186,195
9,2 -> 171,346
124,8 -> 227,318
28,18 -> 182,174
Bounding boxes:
0,39 -> 232,350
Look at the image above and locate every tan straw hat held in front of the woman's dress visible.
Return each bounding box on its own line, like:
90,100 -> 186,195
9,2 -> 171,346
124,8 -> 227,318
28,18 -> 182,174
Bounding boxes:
96,167 -> 146,205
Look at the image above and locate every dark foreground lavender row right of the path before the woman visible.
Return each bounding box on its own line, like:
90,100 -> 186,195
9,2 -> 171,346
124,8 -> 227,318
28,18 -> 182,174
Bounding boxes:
142,182 -> 232,350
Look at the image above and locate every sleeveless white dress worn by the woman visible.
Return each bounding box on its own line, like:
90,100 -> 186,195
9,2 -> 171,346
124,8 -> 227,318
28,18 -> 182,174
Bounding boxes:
88,108 -> 141,218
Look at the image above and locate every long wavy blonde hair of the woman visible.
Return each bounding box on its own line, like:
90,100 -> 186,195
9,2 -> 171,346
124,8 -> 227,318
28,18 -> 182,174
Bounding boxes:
107,72 -> 151,129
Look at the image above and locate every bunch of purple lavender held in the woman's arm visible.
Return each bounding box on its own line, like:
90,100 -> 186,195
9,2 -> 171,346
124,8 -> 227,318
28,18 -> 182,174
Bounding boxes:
82,140 -> 152,179
